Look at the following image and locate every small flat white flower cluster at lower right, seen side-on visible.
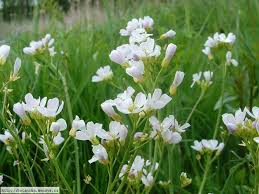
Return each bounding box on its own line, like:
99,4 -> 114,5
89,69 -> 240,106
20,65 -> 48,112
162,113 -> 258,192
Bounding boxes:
191,139 -> 224,155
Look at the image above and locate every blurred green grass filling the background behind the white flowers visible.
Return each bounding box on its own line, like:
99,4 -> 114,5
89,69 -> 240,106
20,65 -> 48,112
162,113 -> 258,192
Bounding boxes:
0,0 -> 259,194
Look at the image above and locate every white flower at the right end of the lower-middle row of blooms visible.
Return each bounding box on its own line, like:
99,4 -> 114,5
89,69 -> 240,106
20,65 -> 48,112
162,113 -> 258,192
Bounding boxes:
104,121 -> 128,142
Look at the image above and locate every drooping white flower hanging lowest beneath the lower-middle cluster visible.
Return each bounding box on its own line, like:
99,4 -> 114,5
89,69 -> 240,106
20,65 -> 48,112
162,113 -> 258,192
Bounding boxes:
88,144 -> 108,164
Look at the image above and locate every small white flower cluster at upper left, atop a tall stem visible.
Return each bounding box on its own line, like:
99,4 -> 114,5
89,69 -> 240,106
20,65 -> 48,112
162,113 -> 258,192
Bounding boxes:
23,34 -> 56,56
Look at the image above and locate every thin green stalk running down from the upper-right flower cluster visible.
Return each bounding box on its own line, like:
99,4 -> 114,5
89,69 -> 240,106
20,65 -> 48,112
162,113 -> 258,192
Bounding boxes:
213,63 -> 227,139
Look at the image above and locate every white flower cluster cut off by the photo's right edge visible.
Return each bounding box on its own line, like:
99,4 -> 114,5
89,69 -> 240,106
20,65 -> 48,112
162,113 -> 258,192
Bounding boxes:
222,106 -> 259,143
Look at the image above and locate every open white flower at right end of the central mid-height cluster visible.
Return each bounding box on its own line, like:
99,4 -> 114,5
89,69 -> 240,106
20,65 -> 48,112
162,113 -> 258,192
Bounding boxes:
144,89 -> 172,111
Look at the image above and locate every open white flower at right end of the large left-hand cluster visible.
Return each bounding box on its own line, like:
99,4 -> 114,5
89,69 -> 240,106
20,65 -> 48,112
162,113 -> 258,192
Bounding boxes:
38,98 -> 64,117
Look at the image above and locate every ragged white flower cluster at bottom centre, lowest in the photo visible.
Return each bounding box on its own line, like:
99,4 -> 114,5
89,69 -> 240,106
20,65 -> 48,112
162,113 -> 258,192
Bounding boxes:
119,155 -> 159,187
